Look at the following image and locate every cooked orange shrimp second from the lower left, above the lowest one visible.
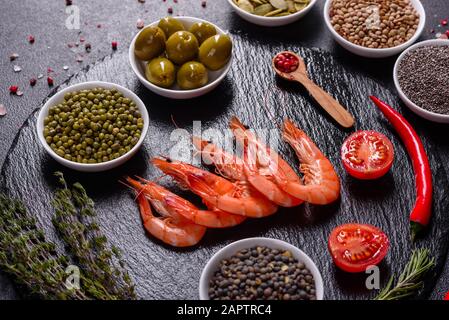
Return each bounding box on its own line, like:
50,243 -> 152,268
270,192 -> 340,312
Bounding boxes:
126,177 -> 246,228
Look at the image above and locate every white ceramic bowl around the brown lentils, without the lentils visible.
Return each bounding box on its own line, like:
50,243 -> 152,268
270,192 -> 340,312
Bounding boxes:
324,0 -> 426,58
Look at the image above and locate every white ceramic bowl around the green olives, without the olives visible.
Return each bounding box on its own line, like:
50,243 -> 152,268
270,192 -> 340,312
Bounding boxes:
129,17 -> 232,99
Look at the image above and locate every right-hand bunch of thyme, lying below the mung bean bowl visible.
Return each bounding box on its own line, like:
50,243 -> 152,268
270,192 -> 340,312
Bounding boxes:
53,172 -> 135,299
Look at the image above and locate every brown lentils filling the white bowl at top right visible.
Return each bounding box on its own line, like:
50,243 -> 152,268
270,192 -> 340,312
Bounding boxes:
329,0 -> 419,49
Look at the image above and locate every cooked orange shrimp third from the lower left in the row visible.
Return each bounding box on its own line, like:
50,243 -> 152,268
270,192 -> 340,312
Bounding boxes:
152,158 -> 277,218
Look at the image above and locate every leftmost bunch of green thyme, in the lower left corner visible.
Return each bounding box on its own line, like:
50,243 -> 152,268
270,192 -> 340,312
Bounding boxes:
0,194 -> 90,299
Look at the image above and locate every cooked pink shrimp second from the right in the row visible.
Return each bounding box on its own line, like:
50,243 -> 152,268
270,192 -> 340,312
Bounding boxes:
230,117 -> 303,207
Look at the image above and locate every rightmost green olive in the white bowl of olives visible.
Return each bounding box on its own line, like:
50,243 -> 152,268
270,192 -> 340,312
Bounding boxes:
199,34 -> 232,70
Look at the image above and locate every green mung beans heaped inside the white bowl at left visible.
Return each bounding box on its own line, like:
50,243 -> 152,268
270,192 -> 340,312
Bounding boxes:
43,88 -> 143,163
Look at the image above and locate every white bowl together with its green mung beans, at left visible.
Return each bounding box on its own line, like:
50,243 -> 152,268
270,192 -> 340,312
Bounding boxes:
37,81 -> 149,172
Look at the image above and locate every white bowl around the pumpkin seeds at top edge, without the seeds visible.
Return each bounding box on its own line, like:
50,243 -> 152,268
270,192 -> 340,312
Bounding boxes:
228,0 -> 317,27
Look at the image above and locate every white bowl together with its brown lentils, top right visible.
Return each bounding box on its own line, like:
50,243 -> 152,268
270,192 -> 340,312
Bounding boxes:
324,0 -> 426,58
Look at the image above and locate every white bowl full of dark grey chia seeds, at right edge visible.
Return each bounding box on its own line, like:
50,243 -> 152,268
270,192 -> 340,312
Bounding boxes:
393,39 -> 449,123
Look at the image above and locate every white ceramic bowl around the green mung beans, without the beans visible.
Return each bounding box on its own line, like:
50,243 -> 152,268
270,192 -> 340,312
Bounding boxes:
37,81 -> 149,172
